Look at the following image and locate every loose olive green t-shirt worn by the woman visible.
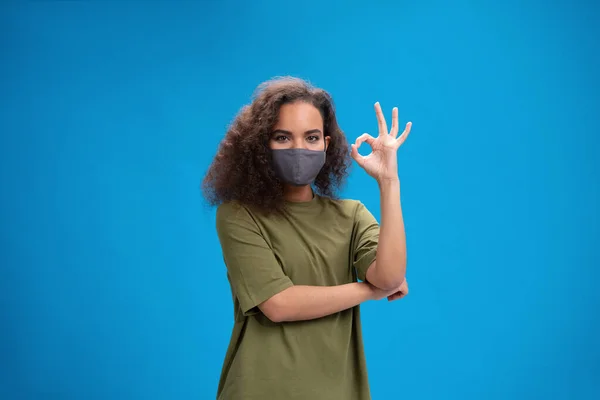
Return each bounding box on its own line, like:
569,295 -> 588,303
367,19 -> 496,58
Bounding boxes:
217,195 -> 379,400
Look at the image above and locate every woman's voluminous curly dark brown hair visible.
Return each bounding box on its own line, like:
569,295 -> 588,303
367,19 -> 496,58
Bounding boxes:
202,77 -> 351,213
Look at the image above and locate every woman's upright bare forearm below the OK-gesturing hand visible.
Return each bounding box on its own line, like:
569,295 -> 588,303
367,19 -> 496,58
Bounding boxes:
367,180 -> 406,289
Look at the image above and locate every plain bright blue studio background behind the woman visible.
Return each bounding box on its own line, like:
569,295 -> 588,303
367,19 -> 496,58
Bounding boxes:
0,1 -> 600,400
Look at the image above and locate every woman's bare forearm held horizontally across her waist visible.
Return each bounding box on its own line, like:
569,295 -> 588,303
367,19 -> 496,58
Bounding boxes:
259,282 -> 374,322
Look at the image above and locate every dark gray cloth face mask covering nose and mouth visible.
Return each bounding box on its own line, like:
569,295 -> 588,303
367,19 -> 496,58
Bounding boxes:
272,149 -> 325,186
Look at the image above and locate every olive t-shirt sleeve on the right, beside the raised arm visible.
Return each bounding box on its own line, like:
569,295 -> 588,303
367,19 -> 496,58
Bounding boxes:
352,202 -> 379,281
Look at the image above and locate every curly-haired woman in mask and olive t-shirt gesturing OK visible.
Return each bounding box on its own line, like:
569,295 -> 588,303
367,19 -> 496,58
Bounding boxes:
203,78 -> 411,400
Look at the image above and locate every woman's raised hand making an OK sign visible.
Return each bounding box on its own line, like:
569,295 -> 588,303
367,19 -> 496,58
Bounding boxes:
351,103 -> 412,183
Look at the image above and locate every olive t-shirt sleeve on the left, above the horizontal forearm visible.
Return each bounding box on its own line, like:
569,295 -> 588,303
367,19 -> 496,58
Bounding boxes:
216,203 -> 293,315
